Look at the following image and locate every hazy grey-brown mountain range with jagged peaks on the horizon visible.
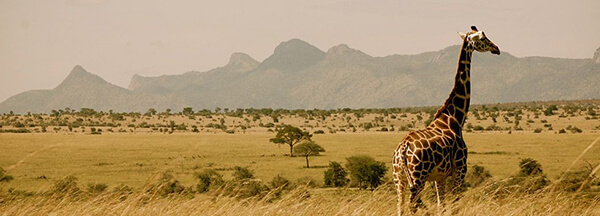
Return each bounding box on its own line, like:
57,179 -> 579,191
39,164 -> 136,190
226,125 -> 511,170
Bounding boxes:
0,39 -> 600,113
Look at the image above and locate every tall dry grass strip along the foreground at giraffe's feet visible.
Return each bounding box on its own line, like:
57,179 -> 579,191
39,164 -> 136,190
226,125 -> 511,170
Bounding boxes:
0,181 -> 600,215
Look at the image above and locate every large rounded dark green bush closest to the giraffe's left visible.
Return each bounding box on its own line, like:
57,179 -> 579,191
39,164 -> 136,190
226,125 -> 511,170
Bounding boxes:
346,155 -> 387,189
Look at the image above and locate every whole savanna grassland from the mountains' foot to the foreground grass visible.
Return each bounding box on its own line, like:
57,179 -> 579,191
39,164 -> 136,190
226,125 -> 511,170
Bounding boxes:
0,101 -> 600,215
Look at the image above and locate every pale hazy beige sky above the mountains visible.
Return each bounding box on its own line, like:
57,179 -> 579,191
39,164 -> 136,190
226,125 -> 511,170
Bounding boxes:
0,0 -> 600,101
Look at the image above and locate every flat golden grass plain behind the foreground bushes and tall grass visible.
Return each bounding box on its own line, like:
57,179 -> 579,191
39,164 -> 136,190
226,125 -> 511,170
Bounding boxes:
0,132 -> 600,191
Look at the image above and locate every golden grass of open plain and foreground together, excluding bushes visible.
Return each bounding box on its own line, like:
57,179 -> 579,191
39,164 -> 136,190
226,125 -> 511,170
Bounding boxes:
0,132 -> 600,215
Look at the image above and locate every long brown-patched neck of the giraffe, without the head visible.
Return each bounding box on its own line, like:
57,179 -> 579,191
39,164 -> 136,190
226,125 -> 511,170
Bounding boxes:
434,37 -> 473,127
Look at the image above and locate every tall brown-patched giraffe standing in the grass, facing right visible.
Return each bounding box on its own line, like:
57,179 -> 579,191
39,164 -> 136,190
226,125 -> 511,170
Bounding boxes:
393,26 -> 500,215
